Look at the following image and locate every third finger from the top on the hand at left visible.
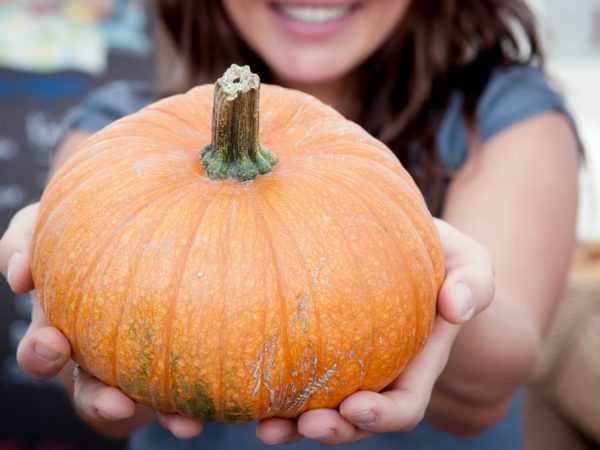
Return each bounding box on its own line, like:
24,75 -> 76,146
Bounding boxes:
73,366 -> 135,421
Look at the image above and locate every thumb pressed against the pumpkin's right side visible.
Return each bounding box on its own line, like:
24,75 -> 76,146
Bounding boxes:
436,219 -> 495,324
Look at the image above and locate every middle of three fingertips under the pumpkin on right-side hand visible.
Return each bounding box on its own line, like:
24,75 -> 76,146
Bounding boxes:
298,409 -> 371,445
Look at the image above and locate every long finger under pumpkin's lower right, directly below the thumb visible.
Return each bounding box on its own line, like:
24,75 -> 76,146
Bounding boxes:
340,317 -> 459,433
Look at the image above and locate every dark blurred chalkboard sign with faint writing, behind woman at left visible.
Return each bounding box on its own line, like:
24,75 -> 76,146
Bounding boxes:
0,54 -> 154,450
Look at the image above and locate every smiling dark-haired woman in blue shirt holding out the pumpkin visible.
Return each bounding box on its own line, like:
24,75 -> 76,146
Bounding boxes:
0,0 -> 577,449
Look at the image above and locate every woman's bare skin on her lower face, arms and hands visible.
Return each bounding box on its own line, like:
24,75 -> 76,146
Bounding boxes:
0,0 -> 577,444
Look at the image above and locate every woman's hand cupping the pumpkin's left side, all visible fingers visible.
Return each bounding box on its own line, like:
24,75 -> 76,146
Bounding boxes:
0,203 -> 202,438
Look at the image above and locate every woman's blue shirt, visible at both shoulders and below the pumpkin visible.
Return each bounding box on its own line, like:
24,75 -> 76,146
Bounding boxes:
66,66 -> 568,450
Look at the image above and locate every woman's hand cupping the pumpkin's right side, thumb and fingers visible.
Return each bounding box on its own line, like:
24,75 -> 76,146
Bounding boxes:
256,220 -> 494,444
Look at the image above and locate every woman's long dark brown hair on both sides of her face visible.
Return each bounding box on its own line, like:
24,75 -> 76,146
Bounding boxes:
156,0 -> 543,211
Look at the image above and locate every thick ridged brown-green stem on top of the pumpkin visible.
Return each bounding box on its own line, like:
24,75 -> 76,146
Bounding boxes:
200,64 -> 277,181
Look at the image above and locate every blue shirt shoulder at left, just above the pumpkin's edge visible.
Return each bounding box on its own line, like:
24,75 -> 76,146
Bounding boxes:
64,81 -> 157,133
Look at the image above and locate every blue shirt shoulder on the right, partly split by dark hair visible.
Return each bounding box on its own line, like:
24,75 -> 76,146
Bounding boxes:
437,65 -> 571,171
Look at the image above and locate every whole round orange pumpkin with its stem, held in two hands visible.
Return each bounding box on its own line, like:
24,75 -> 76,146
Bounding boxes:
32,66 -> 444,422
